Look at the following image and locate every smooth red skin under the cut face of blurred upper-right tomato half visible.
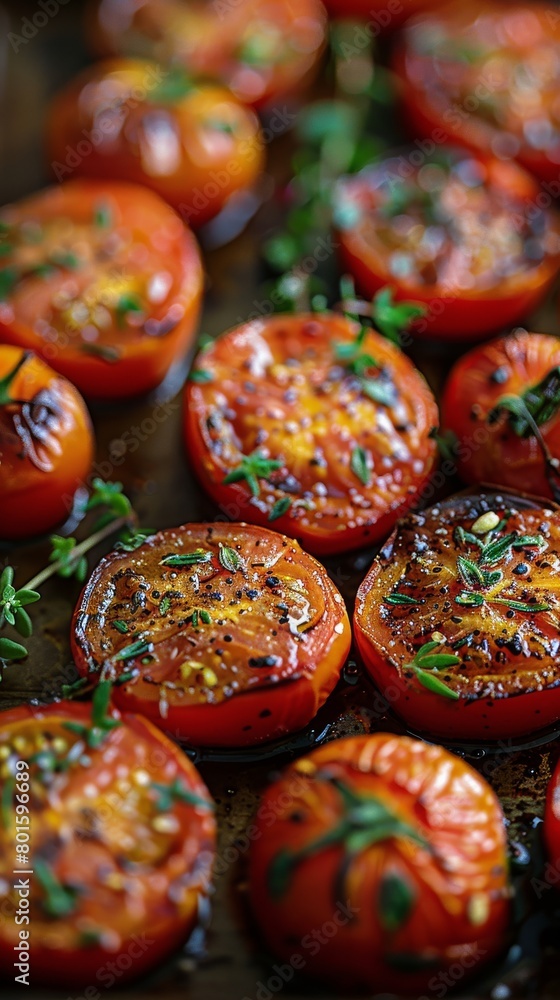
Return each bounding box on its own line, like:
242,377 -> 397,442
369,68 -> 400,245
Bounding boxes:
337,150 -> 559,341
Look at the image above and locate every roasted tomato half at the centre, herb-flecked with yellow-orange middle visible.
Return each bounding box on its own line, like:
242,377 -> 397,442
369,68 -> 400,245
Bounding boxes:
185,313 -> 438,553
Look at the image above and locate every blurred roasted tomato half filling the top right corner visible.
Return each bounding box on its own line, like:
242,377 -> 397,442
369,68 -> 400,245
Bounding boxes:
394,0 -> 560,184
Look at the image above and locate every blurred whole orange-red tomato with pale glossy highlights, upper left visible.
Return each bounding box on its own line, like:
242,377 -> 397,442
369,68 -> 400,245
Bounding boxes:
47,59 -> 264,228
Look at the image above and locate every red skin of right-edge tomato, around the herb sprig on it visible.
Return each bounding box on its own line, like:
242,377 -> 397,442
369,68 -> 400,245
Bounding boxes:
442,330 -> 560,499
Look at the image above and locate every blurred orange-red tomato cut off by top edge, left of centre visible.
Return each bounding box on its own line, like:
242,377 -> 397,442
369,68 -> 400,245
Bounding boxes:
88,0 -> 326,107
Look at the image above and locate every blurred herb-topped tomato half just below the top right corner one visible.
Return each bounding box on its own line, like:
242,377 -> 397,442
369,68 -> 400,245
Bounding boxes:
335,142 -> 560,340
